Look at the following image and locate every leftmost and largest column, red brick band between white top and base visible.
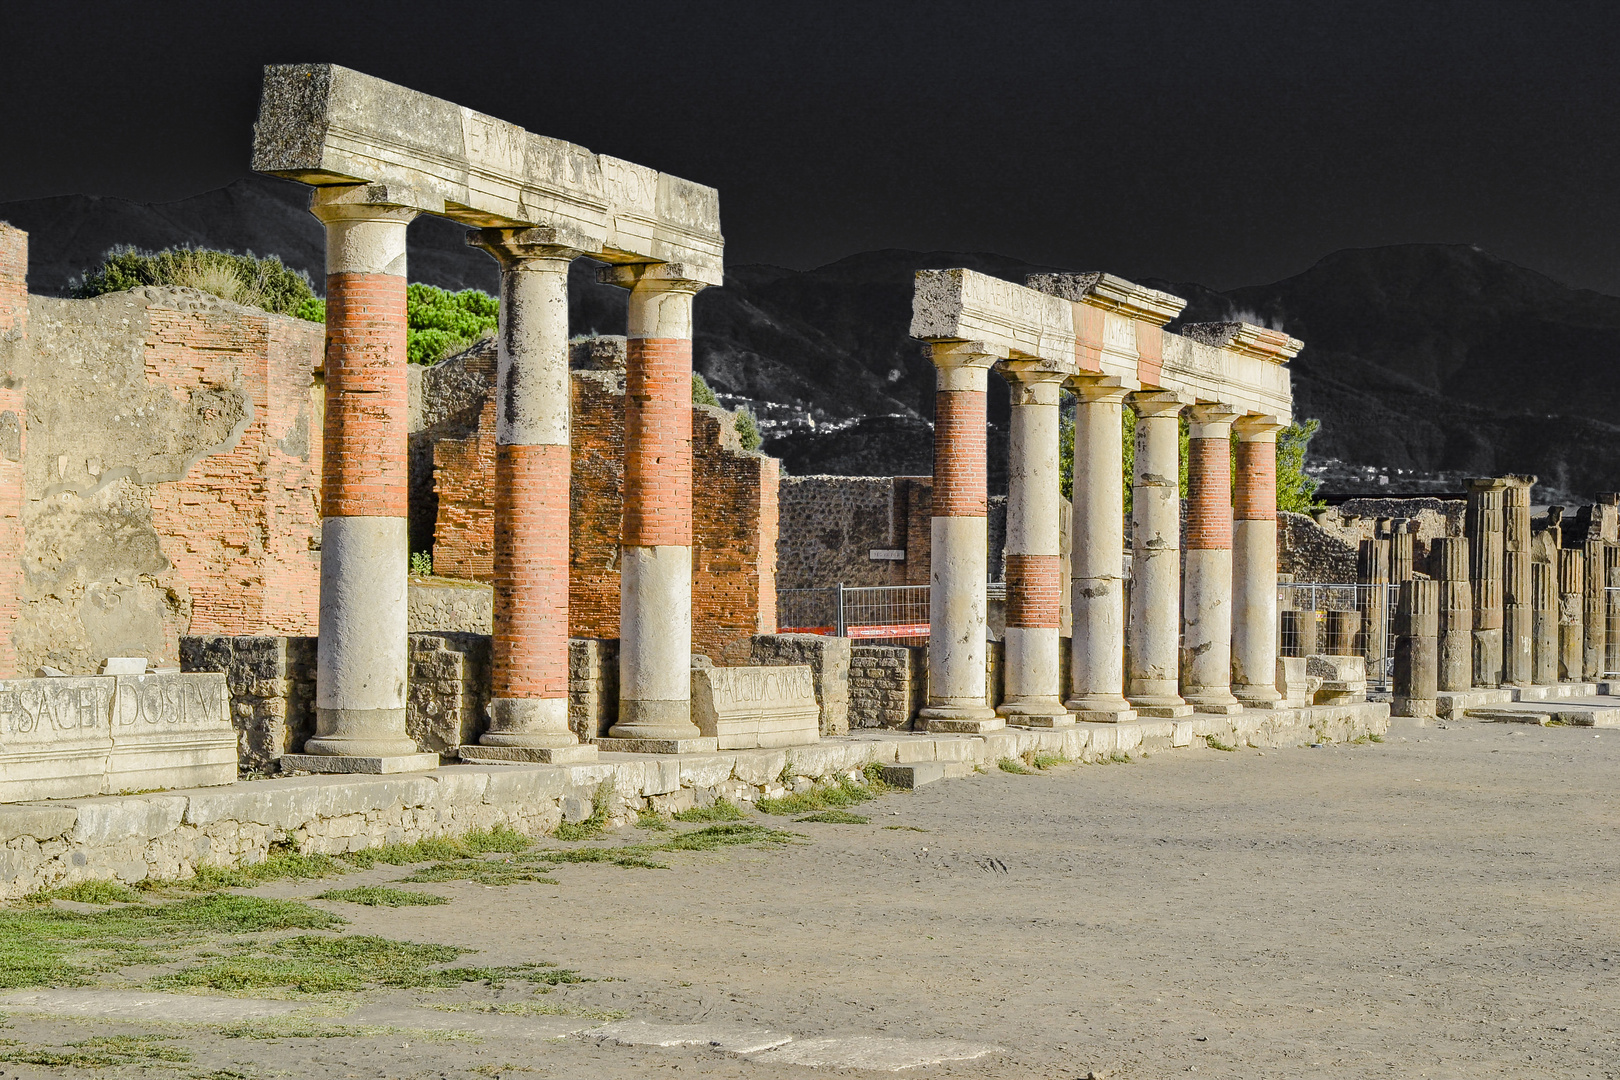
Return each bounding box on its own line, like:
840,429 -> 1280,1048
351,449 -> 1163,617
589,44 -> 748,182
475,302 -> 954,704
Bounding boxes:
294,186 -> 439,772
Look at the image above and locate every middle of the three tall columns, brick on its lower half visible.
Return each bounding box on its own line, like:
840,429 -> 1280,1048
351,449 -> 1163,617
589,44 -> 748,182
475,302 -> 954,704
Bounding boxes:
462,228 -> 596,763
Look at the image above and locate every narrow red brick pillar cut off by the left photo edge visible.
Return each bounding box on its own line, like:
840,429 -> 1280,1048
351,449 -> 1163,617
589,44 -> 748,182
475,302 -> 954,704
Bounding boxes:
0,222 -> 28,678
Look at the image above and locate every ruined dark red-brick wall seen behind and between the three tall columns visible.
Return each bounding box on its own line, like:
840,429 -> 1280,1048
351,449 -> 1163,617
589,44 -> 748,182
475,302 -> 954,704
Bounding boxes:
426,343 -> 779,659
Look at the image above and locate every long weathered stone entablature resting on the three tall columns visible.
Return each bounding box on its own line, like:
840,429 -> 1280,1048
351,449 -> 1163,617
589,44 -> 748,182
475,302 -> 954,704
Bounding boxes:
253,63 -> 724,285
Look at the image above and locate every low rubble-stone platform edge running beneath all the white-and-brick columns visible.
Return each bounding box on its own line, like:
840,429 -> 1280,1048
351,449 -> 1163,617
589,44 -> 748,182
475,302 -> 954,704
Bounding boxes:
0,703 -> 1388,899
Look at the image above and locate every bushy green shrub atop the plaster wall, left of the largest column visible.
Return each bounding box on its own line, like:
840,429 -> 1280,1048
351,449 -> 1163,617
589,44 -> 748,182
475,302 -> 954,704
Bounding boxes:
71,246 -> 314,316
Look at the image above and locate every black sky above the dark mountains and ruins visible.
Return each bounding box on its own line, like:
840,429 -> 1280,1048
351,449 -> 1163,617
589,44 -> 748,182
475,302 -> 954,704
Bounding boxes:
0,0 -> 1620,293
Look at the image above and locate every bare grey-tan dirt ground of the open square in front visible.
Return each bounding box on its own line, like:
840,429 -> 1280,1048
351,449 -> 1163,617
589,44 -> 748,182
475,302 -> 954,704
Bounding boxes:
0,722 -> 1620,1080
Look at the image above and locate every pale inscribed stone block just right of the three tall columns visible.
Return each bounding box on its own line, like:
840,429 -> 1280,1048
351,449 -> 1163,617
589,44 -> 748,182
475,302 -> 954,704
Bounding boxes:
692,664 -> 821,750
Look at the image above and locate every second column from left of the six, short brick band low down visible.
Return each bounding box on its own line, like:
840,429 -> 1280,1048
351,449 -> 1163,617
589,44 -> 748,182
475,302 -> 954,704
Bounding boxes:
996,361 -> 1074,727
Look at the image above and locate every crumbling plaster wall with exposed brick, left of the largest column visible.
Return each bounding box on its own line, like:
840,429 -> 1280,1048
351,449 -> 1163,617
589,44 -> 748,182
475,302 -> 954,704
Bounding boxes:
11,288 -> 322,674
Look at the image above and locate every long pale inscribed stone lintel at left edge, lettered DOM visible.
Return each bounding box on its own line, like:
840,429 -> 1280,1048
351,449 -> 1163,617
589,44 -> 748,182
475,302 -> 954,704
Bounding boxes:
0,672 -> 237,803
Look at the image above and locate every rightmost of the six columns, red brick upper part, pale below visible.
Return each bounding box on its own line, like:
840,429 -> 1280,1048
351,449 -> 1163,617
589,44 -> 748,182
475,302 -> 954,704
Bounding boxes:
1231,416 -> 1283,709
